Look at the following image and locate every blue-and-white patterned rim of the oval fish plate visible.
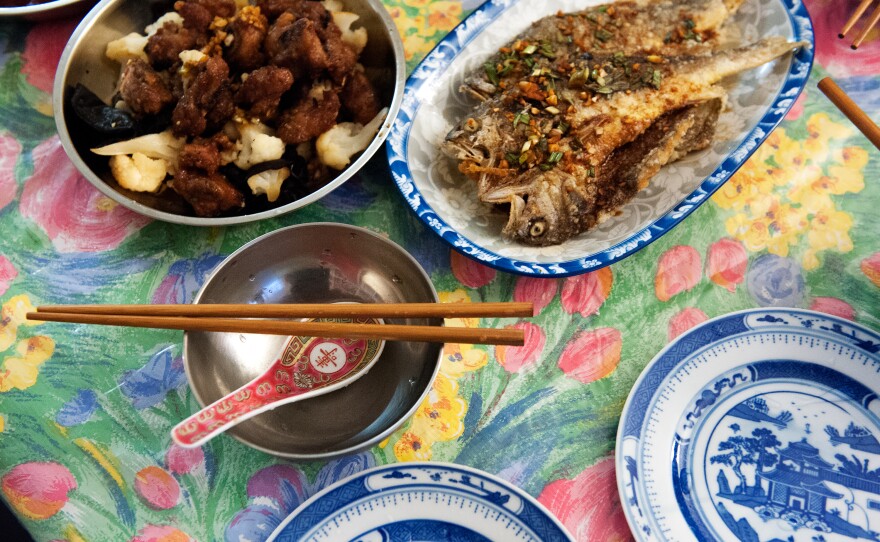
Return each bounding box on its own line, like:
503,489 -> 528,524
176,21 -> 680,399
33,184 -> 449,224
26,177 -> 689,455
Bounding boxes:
386,0 -> 815,277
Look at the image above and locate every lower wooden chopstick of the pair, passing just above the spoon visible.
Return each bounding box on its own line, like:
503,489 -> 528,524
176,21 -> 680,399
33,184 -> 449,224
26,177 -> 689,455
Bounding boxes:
26,311 -> 525,346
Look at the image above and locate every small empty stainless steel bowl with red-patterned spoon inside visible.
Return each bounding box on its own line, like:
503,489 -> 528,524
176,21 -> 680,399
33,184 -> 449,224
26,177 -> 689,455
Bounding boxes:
183,223 -> 443,460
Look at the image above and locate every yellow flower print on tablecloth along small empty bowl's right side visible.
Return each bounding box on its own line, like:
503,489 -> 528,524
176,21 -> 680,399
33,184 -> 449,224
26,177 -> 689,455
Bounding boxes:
393,290 -> 489,461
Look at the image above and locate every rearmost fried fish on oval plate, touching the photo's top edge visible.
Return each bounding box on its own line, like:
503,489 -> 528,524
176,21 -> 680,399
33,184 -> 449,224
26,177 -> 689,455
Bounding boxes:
460,0 -> 743,100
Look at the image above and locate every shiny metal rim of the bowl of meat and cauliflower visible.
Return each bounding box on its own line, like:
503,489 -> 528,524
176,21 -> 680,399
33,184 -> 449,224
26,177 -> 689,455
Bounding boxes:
52,0 -> 406,226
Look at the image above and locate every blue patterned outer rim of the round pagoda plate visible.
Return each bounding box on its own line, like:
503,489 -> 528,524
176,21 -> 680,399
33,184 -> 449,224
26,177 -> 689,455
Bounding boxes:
615,308 -> 880,540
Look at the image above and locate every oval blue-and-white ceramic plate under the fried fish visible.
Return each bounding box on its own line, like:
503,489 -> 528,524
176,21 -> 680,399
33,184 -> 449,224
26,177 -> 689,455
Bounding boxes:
387,0 -> 813,276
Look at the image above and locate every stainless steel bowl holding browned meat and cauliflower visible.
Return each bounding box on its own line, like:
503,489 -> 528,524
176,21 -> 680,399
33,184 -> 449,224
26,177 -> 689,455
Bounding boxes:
53,0 -> 406,226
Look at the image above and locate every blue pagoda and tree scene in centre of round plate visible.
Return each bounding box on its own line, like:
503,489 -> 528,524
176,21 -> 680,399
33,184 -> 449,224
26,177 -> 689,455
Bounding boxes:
705,392 -> 880,542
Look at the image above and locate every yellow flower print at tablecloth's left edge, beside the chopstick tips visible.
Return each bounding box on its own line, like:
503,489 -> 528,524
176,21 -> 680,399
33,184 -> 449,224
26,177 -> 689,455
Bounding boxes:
0,295 -> 55,392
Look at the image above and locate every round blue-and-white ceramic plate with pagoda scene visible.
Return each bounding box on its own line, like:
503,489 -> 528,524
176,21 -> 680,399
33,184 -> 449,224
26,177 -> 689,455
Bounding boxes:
616,309 -> 880,542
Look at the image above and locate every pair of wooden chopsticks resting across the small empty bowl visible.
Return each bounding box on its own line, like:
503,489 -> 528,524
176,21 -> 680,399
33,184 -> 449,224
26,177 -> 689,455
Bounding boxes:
27,303 -> 534,346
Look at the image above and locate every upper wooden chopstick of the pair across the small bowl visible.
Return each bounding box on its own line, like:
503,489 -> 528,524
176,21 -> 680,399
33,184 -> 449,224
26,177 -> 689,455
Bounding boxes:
37,302 -> 534,318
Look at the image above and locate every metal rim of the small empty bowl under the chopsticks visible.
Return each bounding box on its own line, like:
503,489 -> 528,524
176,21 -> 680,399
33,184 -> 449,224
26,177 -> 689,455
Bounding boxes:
183,222 -> 445,461
